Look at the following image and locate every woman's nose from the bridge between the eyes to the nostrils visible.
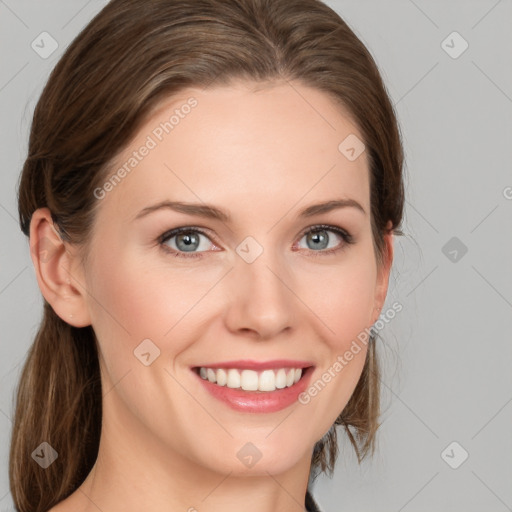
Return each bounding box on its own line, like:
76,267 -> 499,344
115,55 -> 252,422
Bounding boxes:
228,237 -> 296,338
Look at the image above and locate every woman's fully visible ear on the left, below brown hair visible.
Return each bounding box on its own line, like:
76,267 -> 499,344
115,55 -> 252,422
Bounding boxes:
30,208 -> 91,327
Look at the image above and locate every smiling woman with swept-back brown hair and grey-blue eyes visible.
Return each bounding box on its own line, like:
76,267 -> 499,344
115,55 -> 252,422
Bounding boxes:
10,0 -> 404,512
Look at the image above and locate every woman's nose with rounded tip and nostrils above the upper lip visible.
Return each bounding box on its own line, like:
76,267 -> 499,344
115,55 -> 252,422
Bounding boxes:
225,251 -> 299,340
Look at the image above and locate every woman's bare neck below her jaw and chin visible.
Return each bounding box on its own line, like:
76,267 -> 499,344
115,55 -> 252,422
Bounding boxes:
63,393 -> 311,512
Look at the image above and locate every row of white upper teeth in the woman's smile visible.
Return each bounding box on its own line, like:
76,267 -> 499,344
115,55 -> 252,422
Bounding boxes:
199,367 -> 302,391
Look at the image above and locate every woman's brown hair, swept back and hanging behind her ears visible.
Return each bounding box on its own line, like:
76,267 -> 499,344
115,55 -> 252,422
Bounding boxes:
9,0 -> 404,512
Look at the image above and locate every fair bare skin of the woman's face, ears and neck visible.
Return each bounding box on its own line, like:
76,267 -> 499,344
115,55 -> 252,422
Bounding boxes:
31,82 -> 393,512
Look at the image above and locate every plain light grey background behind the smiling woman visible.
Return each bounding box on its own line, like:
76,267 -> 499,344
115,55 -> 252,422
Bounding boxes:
0,0 -> 512,512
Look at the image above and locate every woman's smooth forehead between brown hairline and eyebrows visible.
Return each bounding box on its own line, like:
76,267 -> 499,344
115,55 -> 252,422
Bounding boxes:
97,82 -> 369,222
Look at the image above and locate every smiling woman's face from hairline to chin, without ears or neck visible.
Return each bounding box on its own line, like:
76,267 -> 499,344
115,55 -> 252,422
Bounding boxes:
68,79 -> 390,474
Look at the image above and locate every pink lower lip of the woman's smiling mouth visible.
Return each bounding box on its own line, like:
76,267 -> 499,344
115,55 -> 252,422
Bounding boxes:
194,367 -> 313,413
